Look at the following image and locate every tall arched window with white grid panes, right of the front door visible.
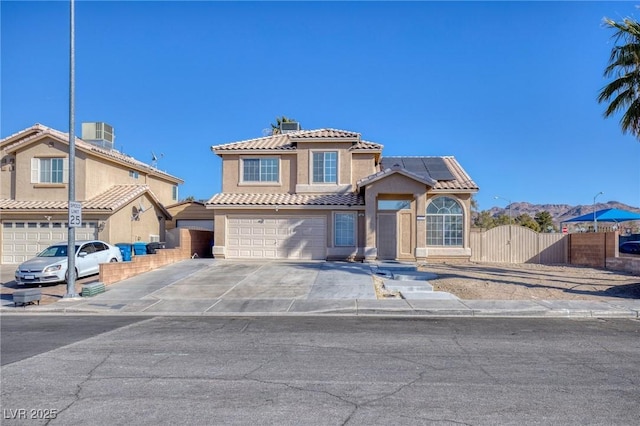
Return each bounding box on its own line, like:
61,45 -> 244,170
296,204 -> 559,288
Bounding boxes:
427,197 -> 464,246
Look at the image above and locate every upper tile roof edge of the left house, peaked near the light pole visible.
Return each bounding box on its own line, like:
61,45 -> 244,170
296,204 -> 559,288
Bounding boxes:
0,124 -> 183,183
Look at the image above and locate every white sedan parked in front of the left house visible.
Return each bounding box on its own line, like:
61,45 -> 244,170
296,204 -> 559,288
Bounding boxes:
15,240 -> 122,285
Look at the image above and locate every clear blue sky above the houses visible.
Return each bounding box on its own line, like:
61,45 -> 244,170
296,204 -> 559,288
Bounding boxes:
0,0 -> 640,210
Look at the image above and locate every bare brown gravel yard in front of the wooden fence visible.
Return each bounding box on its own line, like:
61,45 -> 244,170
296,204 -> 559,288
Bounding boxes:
419,263 -> 640,300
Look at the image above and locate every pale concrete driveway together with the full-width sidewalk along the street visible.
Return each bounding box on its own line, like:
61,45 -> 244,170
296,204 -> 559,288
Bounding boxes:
0,259 -> 640,318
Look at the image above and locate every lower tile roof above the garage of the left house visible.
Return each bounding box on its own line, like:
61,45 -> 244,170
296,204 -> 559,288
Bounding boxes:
0,185 -> 171,217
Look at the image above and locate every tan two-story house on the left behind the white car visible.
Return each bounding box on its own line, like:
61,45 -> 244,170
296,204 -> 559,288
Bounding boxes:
0,123 -> 183,263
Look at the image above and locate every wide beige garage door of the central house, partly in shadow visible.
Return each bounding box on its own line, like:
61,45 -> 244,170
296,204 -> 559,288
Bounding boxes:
226,217 -> 327,260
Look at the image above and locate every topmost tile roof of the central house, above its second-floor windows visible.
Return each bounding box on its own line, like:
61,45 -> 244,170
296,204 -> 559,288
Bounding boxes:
211,129 -> 383,153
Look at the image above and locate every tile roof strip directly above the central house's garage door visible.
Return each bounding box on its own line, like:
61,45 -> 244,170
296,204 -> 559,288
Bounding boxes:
206,193 -> 364,206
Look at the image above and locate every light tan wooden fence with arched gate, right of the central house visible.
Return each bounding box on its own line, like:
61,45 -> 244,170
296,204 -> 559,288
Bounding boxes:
469,225 -> 569,264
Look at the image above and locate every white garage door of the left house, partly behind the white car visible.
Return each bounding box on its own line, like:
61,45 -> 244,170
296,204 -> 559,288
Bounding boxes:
2,221 -> 98,264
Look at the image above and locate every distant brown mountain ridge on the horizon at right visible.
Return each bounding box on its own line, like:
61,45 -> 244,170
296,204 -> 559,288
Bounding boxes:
489,201 -> 640,224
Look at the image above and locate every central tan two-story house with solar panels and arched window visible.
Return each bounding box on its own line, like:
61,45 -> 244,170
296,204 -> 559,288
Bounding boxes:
206,125 -> 478,261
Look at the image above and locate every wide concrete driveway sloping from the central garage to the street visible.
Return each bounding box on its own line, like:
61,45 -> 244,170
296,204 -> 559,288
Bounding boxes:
2,259 -> 384,313
